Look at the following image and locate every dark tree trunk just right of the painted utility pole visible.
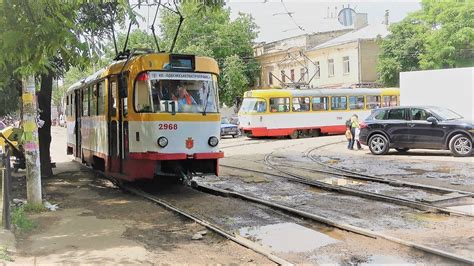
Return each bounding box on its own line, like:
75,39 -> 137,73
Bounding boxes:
38,72 -> 53,177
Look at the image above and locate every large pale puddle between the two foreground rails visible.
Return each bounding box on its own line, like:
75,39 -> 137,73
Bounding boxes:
238,223 -> 339,252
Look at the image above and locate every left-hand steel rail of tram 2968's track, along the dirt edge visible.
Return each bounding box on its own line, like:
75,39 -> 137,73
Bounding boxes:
103,176 -> 294,265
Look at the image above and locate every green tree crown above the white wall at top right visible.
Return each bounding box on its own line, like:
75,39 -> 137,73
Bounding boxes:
377,0 -> 474,86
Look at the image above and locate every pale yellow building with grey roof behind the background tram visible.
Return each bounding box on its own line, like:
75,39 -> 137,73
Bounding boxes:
254,14 -> 388,89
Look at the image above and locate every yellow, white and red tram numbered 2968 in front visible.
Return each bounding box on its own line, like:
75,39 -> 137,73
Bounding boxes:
65,53 -> 224,181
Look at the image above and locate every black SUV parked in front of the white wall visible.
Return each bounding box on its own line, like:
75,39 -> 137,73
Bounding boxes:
359,106 -> 474,156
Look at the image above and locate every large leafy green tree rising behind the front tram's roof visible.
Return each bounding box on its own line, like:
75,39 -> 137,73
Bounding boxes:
160,1 -> 259,105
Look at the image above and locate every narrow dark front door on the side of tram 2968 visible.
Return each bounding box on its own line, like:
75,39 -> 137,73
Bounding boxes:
107,77 -> 122,173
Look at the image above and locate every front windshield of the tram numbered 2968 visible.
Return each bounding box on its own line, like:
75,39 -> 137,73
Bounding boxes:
134,72 -> 218,113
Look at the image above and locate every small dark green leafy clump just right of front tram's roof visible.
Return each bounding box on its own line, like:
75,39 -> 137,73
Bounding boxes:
221,55 -> 249,106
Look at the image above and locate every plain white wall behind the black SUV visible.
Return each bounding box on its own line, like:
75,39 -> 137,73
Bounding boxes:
400,67 -> 474,120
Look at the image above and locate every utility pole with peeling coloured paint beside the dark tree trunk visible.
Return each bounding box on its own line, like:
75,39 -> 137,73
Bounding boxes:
22,76 -> 42,205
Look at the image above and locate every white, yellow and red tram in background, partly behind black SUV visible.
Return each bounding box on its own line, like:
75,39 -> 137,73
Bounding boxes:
239,88 -> 400,138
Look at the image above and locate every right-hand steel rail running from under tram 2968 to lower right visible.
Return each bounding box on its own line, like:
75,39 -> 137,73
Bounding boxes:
197,183 -> 474,265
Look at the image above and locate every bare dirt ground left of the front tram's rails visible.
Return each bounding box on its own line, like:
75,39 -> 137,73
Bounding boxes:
10,162 -> 271,264
